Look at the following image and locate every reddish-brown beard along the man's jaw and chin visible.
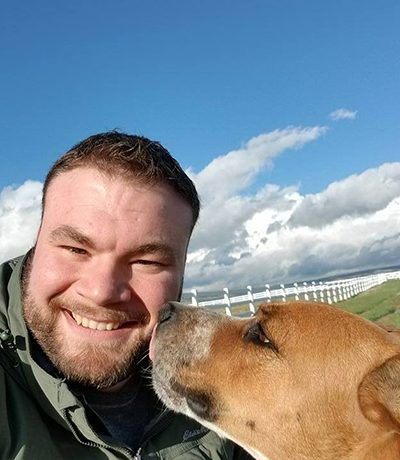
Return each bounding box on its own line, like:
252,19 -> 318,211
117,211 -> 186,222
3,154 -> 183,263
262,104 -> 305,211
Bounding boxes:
22,255 -> 149,389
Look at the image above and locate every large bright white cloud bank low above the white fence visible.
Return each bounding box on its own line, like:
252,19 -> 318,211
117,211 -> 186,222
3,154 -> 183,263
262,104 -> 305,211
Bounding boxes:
187,171 -> 400,290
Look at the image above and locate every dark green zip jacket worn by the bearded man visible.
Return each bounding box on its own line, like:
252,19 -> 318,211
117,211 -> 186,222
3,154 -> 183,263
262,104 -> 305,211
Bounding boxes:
0,257 -> 250,460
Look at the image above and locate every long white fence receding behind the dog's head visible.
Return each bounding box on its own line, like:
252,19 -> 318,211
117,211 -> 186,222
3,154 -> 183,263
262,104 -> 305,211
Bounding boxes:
186,271 -> 400,316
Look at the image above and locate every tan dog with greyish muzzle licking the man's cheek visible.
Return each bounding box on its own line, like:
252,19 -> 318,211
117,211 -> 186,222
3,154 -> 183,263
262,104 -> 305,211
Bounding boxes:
150,302 -> 400,460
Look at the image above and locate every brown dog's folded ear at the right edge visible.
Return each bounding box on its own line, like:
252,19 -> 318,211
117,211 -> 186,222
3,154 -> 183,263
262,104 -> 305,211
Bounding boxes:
358,355 -> 400,433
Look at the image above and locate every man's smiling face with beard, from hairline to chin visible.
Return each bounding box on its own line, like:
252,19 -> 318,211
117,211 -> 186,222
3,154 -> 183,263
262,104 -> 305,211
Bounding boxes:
24,168 -> 192,388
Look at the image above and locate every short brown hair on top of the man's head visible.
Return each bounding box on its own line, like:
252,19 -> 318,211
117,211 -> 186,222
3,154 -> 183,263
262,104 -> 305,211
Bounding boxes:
42,131 -> 200,227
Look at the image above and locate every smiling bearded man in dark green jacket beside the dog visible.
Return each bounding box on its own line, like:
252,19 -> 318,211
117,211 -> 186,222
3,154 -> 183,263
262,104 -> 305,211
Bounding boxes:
0,132 -> 250,460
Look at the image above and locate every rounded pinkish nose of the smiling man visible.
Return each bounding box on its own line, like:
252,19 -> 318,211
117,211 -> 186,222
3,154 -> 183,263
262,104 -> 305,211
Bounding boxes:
77,264 -> 131,305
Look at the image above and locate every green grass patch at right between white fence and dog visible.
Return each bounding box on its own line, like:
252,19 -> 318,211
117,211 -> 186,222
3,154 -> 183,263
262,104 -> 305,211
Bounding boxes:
336,280 -> 400,329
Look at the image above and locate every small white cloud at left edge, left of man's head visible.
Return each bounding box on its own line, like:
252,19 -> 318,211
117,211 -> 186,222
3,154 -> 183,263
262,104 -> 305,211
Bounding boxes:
0,180 -> 42,262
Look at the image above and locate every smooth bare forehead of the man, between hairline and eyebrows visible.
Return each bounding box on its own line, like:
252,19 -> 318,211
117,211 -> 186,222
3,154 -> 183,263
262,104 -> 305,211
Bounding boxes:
43,168 -> 193,233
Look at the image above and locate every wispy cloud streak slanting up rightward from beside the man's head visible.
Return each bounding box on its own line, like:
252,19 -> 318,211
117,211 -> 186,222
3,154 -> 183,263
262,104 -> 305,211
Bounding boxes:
190,126 -> 326,251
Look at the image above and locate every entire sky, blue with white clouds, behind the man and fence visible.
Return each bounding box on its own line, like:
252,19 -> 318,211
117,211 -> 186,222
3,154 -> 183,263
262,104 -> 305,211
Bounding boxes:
0,0 -> 400,290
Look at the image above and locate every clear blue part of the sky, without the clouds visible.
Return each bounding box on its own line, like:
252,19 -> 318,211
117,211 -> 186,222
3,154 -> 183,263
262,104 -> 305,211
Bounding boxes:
0,0 -> 400,285
